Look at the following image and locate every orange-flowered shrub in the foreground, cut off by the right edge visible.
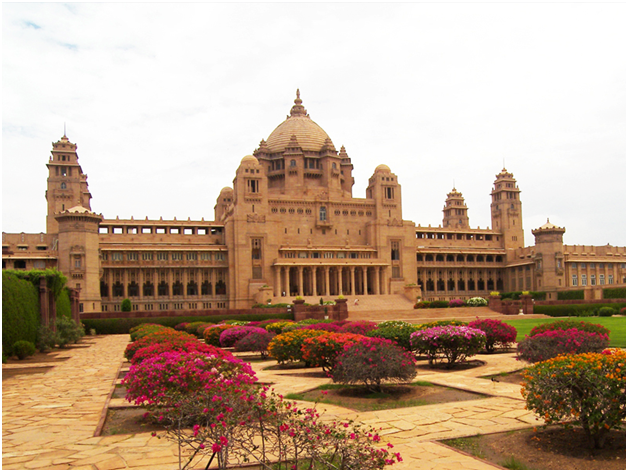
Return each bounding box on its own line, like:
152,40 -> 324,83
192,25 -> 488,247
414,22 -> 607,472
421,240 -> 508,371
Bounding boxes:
521,350 -> 626,449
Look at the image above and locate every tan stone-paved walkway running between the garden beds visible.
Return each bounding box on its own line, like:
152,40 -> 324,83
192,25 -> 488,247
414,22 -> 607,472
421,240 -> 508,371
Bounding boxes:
2,335 -> 541,470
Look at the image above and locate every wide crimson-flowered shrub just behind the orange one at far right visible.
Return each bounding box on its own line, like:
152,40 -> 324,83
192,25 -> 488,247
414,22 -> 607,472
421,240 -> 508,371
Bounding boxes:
517,328 -> 608,362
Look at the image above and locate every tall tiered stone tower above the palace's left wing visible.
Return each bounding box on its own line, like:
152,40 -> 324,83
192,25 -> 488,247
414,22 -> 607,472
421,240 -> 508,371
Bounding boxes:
46,134 -> 92,234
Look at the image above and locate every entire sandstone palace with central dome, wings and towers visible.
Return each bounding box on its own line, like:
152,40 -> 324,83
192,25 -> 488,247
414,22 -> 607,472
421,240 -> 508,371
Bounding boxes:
2,91 -> 626,312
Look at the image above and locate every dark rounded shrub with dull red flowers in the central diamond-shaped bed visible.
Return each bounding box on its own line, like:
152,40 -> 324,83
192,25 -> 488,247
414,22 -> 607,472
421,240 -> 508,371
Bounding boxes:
331,338 -> 416,391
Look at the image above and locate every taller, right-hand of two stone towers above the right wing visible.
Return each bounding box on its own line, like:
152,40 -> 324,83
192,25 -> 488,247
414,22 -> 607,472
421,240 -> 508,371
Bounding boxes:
491,169 -> 524,249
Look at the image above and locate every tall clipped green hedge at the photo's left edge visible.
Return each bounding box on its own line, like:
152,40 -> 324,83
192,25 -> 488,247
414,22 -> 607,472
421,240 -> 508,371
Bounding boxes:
2,270 -> 41,355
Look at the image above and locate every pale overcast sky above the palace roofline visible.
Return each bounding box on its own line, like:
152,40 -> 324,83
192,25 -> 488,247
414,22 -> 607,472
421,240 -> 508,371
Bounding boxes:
2,3 -> 627,246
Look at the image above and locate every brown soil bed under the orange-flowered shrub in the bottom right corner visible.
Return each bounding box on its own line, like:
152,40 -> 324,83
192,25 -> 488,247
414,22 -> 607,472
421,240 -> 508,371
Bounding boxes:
442,426 -> 626,470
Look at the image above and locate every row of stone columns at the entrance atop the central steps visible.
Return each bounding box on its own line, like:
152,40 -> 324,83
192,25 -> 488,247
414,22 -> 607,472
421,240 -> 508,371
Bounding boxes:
274,265 -> 389,297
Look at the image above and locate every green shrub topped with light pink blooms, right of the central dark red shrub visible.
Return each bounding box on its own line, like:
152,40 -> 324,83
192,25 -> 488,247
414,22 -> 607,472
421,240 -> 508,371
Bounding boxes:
410,326 -> 486,368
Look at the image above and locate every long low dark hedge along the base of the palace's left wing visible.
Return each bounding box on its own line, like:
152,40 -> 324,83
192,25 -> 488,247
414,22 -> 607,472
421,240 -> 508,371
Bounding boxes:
81,313 -> 294,334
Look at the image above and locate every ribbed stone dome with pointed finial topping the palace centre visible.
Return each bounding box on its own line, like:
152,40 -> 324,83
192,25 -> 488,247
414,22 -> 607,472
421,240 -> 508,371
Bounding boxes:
266,90 -> 331,153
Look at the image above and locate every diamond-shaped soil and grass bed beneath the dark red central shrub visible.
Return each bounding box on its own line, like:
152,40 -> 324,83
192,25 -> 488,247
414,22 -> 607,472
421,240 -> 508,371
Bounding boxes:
286,382 -> 486,411
